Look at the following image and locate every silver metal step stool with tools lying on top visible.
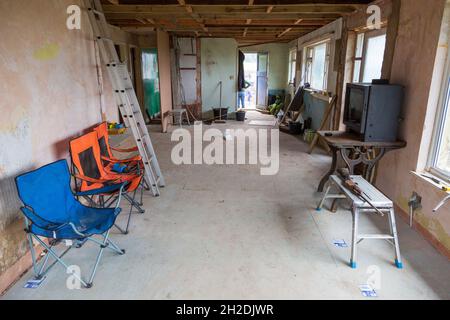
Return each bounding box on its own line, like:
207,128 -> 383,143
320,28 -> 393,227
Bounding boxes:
317,175 -> 403,269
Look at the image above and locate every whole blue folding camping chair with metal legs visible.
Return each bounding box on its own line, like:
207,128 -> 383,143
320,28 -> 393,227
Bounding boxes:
16,160 -> 125,288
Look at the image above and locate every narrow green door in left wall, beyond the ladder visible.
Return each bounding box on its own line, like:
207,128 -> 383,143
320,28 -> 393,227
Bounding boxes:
142,49 -> 161,117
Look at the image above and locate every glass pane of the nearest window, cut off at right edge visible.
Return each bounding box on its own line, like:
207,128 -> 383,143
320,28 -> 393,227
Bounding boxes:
430,67 -> 450,181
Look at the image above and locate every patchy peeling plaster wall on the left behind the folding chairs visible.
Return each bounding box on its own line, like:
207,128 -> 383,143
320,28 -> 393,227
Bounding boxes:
0,0 -> 123,292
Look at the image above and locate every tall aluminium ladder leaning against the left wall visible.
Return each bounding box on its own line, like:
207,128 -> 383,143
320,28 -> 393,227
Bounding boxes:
84,0 -> 165,196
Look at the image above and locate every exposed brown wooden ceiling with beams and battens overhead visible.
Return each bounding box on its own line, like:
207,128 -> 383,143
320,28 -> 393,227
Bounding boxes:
102,0 -> 370,45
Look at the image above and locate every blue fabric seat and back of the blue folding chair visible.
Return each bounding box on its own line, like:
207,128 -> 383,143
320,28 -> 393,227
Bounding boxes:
16,160 -> 121,239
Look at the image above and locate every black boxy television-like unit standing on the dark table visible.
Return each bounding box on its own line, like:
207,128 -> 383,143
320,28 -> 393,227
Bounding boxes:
344,83 -> 404,142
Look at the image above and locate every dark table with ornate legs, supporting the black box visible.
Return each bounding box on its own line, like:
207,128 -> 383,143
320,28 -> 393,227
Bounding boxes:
318,131 -> 406,192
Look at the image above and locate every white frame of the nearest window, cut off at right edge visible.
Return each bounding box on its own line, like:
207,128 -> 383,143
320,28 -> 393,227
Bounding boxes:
428,50 -> 450,182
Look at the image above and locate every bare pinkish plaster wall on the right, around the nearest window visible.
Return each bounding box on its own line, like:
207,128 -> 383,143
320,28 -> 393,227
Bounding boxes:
377,0 -> 450,255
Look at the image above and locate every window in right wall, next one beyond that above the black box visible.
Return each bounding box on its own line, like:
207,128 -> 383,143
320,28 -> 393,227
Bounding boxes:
305,41 -> 330,91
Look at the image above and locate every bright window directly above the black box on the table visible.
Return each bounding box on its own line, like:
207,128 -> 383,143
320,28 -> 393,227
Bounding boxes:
353,29 -> 386,82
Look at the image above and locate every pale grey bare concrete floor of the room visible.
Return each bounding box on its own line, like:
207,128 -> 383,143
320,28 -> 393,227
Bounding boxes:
3,113 -> 450,299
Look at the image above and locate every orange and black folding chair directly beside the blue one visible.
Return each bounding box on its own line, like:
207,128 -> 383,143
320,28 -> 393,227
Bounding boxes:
70,132 -> 145,234
